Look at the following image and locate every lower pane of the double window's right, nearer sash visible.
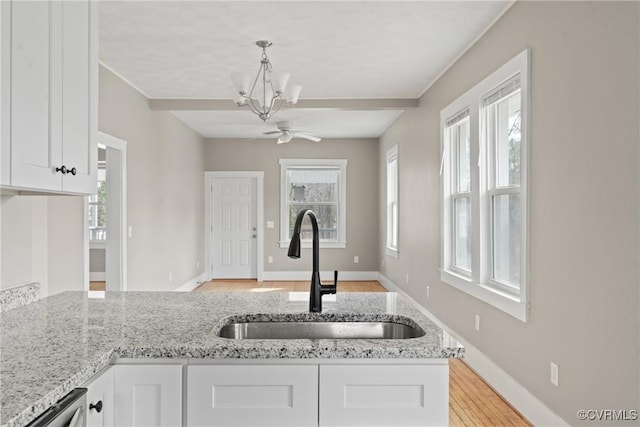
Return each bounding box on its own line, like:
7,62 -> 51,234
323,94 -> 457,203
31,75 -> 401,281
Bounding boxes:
492,194 -> 521,288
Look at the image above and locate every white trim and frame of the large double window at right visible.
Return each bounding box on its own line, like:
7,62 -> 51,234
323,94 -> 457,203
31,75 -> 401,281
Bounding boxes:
440,49 -> 531,322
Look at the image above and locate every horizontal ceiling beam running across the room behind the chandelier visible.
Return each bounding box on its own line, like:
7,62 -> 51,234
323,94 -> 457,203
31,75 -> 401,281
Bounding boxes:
149,98 -> 418,111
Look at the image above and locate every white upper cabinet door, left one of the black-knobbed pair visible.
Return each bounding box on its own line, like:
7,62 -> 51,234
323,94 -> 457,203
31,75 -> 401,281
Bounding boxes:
7,1 -> 62,191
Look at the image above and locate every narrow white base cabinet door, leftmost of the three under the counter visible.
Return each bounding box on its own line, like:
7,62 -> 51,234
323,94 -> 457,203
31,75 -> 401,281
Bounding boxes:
114,364 -> 182,427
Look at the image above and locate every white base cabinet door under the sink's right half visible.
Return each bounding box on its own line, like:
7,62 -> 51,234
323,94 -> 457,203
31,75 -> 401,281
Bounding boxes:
320,360 -> 449,427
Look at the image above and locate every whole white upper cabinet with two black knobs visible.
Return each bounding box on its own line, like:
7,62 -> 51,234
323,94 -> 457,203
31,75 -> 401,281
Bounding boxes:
0,0 -> 98,194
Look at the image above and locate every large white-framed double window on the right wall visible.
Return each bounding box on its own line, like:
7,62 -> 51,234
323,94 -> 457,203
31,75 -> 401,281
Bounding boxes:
441,50 -> 529,321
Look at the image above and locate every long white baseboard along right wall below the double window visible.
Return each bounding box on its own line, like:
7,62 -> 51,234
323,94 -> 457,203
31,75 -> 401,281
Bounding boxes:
378,273 -> 569,426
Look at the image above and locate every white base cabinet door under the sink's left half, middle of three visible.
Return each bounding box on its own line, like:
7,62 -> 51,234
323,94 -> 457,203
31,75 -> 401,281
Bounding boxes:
187,365 -> 318,427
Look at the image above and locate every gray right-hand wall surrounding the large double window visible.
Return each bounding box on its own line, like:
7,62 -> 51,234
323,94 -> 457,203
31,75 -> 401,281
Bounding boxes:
378,2 -> 640,425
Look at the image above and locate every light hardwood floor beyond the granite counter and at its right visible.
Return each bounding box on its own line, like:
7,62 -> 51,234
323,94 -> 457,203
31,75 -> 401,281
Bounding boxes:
195,280 -> 531,427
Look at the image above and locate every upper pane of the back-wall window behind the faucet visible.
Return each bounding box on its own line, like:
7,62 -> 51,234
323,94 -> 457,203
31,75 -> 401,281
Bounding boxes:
287,169 -> 338,204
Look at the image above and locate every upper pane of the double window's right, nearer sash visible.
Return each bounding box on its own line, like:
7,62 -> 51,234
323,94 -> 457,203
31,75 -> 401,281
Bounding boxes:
495,90 -> 522,187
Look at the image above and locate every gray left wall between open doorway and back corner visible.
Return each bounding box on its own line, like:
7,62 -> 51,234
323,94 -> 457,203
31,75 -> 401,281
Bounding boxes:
99,67 -> 204,291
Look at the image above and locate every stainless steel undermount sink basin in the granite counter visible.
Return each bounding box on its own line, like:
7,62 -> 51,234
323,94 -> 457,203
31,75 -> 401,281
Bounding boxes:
218,321 -> 425,340
